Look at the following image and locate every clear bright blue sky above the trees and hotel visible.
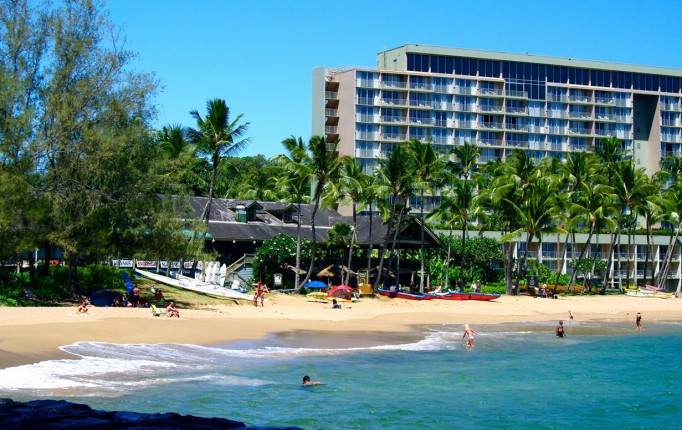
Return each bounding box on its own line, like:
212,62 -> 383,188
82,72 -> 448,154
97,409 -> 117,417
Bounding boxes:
109,0 -> 682,157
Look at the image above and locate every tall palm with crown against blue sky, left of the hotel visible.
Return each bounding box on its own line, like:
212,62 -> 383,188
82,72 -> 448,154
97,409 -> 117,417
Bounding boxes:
187,99 -> 251,235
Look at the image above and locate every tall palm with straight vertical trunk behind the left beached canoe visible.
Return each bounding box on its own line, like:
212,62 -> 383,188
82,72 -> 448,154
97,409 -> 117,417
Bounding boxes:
408,137 -> 442,293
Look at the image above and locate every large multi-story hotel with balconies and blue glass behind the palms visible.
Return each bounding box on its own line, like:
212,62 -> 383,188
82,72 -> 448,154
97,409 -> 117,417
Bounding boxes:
312,45 -> 682,292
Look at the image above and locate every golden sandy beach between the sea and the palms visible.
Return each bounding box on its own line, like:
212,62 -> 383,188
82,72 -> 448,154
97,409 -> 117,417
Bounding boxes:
0,293 -> 682,368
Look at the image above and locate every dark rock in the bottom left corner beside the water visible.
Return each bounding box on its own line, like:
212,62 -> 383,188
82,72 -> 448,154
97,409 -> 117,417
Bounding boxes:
0,399 -> 298,430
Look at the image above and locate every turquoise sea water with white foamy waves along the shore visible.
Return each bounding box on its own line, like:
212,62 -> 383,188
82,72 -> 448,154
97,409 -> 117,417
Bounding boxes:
0,322 -> 682,429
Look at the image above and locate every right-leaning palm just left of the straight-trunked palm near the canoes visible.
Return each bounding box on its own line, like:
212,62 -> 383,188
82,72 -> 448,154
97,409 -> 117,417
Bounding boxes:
374,143 -> 415,289
